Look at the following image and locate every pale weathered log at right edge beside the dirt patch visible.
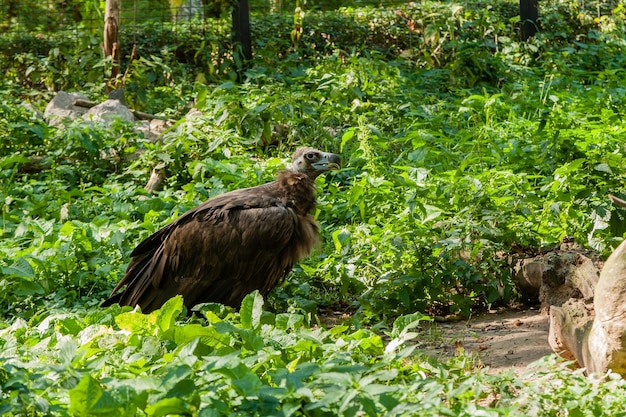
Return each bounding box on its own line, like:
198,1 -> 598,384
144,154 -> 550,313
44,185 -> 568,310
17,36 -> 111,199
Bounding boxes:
513,236 -> 626,377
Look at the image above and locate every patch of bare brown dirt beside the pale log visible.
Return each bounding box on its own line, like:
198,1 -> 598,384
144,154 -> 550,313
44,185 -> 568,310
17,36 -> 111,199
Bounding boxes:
426,309 -> 553,374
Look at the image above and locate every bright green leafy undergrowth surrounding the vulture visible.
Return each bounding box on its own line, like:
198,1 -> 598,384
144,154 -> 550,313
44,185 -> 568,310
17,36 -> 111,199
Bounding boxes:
0,1 -> 626,416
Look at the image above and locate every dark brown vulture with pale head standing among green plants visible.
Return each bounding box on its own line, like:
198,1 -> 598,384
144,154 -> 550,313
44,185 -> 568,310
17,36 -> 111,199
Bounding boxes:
102,148 -> 341,313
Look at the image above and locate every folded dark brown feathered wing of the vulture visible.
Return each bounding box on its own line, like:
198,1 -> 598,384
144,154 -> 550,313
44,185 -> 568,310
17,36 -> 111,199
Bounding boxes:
108,190 -> 298,311
